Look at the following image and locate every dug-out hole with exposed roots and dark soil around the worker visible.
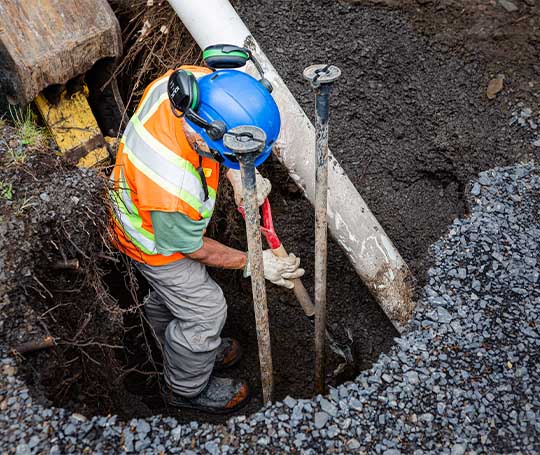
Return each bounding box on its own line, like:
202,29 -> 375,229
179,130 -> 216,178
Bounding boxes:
0,131 -> 396,421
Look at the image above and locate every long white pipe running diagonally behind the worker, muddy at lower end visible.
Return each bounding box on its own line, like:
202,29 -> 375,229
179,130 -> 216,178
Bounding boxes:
168,0 -> 414,329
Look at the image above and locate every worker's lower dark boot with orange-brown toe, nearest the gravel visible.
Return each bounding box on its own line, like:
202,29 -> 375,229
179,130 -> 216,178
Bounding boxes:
163,376 -> 249,414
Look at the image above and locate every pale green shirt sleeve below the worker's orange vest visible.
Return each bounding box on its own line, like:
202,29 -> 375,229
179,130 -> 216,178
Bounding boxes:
150,211 -> 206,256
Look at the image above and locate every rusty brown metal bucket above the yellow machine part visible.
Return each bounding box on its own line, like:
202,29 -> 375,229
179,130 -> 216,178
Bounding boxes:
0,0 -> 122,104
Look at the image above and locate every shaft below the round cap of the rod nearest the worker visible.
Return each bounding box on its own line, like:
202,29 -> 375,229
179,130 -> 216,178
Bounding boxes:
239,154 -> 274,404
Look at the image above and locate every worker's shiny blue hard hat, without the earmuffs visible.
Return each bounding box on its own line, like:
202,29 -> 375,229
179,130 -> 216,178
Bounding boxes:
186,70 -> 281,169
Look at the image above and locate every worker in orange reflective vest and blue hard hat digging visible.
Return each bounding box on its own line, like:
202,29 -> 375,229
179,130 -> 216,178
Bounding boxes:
110,62 -> 304,413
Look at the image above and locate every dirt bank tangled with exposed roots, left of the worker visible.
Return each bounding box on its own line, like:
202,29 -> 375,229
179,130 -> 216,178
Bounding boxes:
0,123 -> 132,411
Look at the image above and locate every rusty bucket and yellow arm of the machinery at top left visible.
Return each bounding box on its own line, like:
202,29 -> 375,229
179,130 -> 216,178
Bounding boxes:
0,0 -> 122,167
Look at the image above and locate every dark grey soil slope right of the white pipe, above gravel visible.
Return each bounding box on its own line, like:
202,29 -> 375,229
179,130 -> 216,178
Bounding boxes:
240,0 -> 532,279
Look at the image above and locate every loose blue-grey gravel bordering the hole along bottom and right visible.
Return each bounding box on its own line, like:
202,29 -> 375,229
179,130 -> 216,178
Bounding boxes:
0,165 -> 540,455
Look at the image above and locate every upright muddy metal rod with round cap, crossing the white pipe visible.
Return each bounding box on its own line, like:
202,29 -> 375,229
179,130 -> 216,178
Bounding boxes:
304,65 -> 341,393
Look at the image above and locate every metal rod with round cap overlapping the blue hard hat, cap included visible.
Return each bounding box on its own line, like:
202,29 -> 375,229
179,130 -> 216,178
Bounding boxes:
223,126 -> 274,404
